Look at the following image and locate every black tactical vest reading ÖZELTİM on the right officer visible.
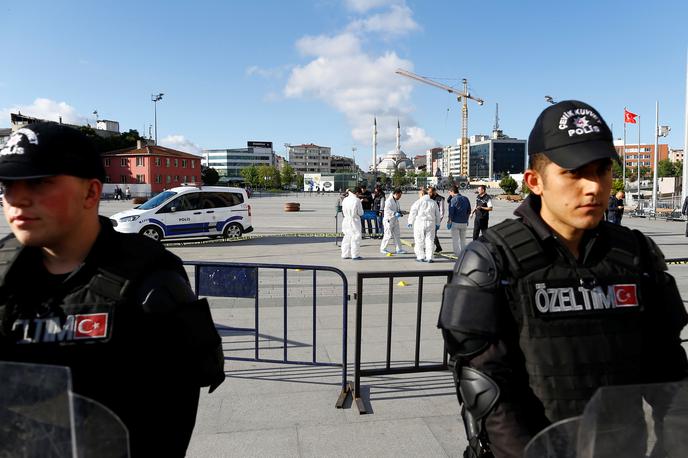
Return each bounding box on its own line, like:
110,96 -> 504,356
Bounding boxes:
485,220 -> 652,421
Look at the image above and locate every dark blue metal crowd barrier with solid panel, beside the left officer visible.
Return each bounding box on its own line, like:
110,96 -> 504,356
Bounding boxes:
184,261 -> 349,408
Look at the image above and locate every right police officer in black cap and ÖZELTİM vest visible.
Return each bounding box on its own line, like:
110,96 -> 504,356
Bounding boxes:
439,101 -> 688,457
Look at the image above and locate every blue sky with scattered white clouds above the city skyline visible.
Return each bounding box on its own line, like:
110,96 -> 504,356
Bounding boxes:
0,0 -> 688,169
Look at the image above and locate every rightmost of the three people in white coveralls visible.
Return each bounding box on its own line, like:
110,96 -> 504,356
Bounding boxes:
408,189 -> 440,262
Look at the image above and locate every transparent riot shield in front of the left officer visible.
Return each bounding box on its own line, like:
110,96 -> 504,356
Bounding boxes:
0,362 -> 129,458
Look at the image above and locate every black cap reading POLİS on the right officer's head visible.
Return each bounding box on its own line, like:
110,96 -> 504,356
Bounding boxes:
528,100 -> 619,170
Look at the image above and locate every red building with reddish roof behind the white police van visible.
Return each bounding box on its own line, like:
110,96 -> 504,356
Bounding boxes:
102,145 -> 201,194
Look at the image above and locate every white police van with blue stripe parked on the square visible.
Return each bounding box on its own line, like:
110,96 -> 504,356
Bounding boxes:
110,186 -> 253,240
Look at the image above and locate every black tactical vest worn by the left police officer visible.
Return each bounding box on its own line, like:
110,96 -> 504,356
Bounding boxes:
0,233 -> 183,366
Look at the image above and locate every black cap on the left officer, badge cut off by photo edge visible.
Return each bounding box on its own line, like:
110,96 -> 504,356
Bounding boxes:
0,122 -> 105,181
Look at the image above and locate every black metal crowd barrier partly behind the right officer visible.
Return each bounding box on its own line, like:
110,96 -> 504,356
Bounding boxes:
349,270 -> 454,414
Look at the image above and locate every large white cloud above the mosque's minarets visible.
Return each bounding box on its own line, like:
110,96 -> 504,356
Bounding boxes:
284,0 -> 438,166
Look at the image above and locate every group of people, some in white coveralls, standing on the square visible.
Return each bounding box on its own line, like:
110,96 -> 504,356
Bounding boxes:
341,185 -> 492,262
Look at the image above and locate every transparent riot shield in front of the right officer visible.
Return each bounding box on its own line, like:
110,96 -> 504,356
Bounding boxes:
524,382 -> 688,458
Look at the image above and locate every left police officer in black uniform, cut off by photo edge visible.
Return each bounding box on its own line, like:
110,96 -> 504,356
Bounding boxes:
0,123 -> 224,457
